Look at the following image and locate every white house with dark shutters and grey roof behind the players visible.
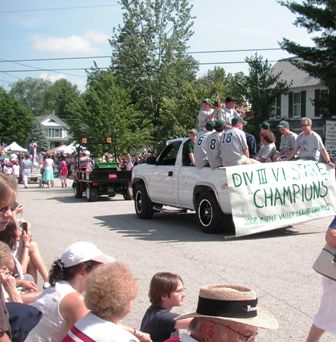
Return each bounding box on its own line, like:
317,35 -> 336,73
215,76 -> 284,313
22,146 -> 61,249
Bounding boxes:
271,58 -> 328,135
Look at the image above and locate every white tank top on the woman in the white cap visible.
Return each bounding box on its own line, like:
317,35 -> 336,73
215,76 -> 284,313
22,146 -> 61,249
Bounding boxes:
26,281 -> 76,342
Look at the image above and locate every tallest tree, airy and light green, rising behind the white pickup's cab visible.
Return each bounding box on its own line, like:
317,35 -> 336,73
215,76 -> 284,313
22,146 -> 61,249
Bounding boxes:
110,0 -> 197,146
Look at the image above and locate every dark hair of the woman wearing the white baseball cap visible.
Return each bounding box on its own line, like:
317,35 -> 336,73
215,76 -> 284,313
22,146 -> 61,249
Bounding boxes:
49,259 -> 100,286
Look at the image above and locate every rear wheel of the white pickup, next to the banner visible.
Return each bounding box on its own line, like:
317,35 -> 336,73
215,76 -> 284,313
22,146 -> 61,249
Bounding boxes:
196,191 -> 223,234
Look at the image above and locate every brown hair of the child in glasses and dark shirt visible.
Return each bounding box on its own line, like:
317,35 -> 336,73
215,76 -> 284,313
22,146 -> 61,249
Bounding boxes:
148,272 -> 183,306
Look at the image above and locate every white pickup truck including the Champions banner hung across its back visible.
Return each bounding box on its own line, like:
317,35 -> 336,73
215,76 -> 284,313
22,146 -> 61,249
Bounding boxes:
132,138 -> 336,236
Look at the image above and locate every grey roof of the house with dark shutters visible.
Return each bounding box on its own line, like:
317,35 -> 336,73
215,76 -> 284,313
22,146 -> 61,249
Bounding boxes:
271,58 -> 322,88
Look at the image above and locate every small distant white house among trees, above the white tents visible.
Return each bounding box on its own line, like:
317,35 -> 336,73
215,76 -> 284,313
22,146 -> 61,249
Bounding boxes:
38,114 -> 71,149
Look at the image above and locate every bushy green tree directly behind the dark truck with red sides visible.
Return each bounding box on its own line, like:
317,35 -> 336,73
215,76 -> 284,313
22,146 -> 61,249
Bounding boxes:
66,69 -> 152,154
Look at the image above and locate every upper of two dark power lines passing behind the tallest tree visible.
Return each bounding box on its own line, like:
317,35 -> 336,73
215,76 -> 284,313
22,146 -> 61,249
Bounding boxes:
0,48 -> 282,63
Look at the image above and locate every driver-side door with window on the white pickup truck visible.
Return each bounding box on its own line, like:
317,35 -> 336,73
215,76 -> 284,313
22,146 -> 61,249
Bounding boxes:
148,141 -> 181,205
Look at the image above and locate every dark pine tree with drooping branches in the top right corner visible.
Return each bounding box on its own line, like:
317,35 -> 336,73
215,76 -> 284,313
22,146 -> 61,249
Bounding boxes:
280,0 -> 336,116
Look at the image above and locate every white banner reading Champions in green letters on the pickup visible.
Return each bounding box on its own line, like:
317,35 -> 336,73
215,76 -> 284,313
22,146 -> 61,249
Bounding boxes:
226,161 -> 336,236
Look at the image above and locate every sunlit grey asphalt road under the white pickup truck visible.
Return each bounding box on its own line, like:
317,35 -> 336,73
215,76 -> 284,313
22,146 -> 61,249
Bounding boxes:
18,179 -> 336,342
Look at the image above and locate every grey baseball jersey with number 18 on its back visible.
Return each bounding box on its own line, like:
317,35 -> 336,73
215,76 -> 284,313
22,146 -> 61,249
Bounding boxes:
221,127 -> 248,166
